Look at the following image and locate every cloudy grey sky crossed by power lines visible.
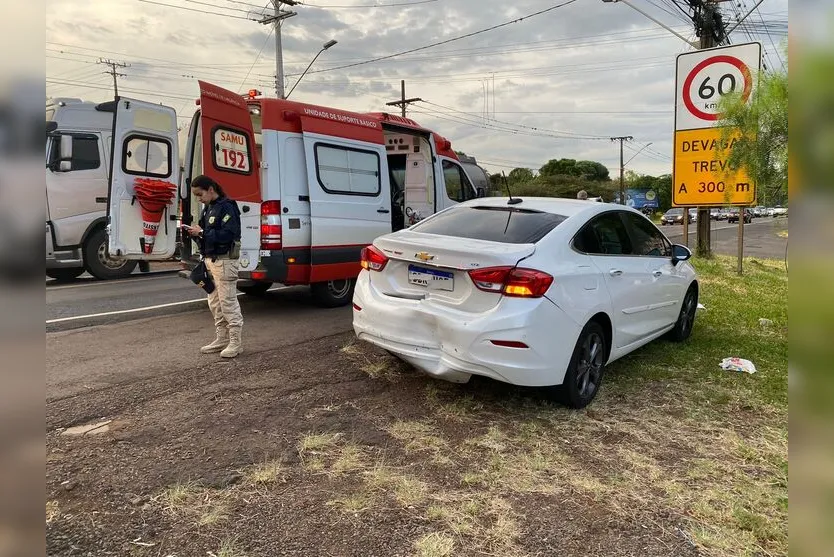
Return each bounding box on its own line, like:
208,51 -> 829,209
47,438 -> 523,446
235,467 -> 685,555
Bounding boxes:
46,0 -> 788,176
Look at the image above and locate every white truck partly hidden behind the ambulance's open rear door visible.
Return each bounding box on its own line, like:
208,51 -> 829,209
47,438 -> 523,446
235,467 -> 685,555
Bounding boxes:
46,98 -> 137,280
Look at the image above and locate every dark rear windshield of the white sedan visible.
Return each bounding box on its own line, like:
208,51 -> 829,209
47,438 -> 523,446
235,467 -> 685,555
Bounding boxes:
411,207 -> 567,244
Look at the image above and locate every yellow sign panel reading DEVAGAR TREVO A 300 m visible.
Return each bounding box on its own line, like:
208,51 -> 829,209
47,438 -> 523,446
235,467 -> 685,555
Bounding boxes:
672,128 -> 756,207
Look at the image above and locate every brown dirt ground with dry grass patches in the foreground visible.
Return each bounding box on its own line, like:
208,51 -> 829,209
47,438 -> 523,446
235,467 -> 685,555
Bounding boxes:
46,324 -> 784,557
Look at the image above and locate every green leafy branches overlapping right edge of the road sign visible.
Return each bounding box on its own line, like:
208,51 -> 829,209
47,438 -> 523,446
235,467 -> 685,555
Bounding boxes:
719,68 -> 788,204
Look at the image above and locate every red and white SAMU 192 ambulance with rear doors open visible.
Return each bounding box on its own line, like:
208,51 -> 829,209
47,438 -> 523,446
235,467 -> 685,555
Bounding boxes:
107,81 -> 486,307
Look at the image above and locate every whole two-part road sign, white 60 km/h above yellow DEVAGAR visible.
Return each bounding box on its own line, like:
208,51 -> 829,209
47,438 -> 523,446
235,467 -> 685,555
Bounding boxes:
672,43 -> 762,207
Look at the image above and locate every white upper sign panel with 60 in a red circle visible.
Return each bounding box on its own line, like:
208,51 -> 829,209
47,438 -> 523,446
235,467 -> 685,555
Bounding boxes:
675,43 -> 762,130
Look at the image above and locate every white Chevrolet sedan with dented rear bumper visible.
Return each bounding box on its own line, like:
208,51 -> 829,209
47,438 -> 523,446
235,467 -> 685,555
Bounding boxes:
353,198 -> 698,408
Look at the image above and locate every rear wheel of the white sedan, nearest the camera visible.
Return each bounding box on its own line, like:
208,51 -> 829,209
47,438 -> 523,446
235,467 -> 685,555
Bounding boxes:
561,321 -> 608,409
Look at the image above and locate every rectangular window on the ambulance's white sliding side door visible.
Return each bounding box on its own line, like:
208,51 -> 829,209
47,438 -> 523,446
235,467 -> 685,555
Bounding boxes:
316,143 -> 382,196
